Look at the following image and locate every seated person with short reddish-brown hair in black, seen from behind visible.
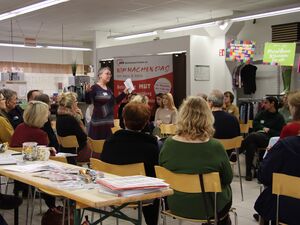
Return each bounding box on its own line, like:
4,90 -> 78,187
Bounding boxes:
100,102 -> 159,225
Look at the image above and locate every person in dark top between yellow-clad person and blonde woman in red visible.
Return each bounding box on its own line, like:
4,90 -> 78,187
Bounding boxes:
1,88 -> 23,129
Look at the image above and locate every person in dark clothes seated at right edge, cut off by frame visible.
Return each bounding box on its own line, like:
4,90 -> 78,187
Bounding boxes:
254,136 -> 300,225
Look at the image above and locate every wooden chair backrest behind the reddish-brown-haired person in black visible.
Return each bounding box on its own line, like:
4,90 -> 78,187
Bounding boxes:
90,158 -> 146,176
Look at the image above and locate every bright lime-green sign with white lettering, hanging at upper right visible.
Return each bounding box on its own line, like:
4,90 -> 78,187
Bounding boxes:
263,42 -> 296,66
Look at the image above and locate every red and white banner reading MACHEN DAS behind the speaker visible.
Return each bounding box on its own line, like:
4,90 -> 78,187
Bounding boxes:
114,55 -> 173,112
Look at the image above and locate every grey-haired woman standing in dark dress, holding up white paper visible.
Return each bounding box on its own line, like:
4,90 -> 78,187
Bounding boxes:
86,67 -> 127,140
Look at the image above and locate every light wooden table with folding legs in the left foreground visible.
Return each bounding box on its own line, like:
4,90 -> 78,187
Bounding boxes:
0,155 -> 173,225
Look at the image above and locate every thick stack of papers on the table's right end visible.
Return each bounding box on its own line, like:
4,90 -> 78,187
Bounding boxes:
97,175 -> 169,196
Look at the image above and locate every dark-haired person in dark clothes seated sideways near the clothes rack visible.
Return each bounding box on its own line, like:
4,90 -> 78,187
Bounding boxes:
241,96 -> 285,181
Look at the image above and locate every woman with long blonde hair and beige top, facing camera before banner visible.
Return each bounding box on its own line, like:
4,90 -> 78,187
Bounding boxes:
154,93 -> 177,127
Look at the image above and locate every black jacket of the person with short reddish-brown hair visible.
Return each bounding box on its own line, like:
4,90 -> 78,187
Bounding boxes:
100,130 -> 159,177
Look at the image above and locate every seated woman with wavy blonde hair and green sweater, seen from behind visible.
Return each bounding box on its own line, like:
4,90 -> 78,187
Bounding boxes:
159,97 -> 233,225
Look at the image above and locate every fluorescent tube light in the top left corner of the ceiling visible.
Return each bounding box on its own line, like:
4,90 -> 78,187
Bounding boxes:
0,0 -> 69,21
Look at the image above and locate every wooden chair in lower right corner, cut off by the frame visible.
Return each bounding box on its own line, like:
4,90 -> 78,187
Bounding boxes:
272,173 -> 300,225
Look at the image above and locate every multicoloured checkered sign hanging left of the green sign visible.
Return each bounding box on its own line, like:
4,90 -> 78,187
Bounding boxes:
225,40 -> 255,63
